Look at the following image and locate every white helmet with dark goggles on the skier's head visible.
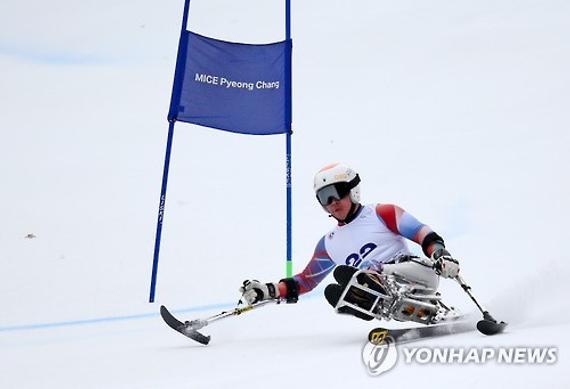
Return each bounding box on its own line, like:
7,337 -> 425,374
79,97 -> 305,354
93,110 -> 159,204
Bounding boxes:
313,163 -> 360,207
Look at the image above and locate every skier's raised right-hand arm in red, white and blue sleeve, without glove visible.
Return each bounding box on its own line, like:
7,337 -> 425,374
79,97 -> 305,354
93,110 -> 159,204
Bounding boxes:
376,204 -> 445,257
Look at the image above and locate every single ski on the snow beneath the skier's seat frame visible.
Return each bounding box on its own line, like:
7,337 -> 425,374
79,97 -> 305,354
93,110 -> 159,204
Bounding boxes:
368,320 -> 475,344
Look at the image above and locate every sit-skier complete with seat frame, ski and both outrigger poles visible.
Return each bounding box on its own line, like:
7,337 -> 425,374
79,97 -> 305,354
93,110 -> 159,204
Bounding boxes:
160,163 -> 507,345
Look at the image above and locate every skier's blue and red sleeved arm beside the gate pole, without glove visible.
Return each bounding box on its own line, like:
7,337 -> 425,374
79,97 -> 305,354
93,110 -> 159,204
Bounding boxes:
279,237 -> 336,300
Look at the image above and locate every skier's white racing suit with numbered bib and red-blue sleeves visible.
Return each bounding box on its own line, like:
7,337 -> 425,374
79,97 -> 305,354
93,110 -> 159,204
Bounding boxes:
281,204 -> 445,299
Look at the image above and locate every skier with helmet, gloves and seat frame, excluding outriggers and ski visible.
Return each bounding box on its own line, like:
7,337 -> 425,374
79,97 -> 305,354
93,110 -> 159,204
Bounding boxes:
240,163 -> 459,322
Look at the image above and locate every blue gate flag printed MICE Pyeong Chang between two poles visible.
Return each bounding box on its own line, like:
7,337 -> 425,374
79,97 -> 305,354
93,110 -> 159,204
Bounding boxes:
168,31 -> 291,135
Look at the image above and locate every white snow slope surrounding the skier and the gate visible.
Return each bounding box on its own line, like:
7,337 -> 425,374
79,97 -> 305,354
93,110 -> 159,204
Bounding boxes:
0,0 -> 570,388
